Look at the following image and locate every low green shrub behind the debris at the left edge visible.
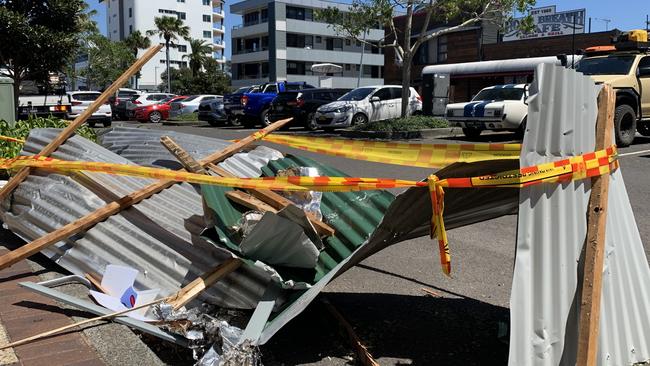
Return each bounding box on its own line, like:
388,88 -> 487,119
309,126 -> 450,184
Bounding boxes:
0,117 -> 97,158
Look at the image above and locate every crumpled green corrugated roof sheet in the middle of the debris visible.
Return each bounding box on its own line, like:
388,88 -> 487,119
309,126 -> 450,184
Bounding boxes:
202,155 -> 395,283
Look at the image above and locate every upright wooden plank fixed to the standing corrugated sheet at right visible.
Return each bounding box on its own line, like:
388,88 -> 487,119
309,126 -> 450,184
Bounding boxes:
577,84 -> 616,366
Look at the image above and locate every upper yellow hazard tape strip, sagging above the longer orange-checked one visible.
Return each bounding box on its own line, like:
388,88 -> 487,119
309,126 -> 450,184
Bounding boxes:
263,135 -> 521,168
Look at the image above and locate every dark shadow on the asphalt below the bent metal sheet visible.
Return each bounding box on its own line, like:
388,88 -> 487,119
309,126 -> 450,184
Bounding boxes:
262,293 -> 508,365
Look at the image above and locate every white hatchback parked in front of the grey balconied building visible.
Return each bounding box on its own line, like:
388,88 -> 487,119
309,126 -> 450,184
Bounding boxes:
314,85 -> 422,129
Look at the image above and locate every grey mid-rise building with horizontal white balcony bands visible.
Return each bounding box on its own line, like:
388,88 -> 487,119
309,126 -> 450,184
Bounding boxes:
230,0 -> 384,88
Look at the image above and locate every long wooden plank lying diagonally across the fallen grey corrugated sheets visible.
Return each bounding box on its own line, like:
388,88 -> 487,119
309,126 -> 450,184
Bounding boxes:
0,118 -> 291,269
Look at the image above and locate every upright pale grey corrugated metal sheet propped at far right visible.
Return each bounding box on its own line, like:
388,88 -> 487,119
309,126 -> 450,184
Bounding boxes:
509,64 -> 650,366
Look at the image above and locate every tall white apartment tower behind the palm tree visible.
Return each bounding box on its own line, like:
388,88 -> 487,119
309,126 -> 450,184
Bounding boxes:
100,0 -> 226,90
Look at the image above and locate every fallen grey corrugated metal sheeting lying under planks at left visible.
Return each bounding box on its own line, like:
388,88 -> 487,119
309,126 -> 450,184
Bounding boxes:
2,130 -> 286,308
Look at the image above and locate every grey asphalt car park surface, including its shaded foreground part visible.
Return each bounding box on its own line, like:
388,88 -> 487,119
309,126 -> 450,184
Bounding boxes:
107,123 -> 650,365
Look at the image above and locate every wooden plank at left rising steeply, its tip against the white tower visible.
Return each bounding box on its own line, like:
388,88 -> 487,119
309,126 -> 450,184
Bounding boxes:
0,45 -> 162,201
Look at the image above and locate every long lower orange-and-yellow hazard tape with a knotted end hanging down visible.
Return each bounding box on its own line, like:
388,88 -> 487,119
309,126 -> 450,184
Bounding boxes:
0,146 -> 618,275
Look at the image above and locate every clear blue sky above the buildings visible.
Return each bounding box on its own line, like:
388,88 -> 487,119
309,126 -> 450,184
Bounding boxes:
86,0 -> 650,59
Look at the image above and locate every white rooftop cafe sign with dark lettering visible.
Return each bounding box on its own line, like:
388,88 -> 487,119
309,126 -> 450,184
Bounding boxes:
503,5 -> 586,42
